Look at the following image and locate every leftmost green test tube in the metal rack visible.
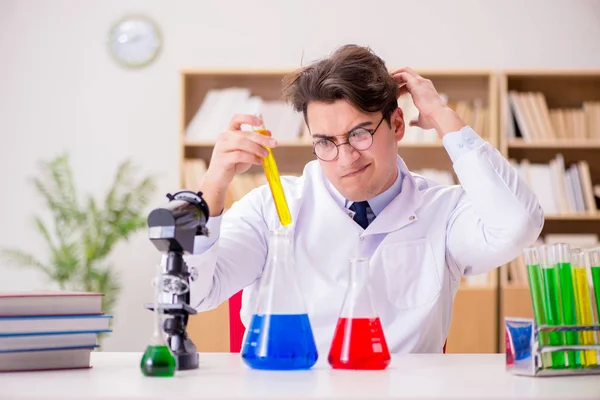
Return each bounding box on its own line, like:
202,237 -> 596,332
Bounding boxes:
523,247 -> 552,368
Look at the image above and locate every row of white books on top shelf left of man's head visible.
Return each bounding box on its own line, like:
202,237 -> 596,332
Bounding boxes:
185,87 -> 304,142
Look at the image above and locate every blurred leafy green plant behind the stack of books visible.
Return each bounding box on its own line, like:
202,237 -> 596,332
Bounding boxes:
2,154 -> 155,314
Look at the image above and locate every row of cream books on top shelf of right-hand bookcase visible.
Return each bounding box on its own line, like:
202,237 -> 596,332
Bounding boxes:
507,90 -> 600,143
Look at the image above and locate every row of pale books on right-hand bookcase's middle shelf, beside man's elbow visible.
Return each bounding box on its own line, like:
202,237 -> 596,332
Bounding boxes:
509,153 -> 600,215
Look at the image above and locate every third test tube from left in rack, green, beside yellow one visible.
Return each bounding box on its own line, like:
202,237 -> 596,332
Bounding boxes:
551,243 -> 581,368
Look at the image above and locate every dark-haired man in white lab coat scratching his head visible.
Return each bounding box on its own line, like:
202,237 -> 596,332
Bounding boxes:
187,45 -> 544,354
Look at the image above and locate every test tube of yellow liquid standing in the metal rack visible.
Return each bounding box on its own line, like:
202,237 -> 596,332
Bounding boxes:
571,249 -> 598,367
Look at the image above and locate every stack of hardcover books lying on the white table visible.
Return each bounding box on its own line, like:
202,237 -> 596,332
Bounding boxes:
0,292 -> 111,372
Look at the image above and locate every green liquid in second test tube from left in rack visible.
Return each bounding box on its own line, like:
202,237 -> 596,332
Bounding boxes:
542,267 -> 565,368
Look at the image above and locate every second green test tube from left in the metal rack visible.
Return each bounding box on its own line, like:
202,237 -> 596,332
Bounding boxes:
539,245 -> 565,368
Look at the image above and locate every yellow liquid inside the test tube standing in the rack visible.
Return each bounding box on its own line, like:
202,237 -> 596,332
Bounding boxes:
573,267 -> 597,367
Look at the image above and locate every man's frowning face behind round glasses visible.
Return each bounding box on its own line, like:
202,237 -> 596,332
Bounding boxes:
307,100 -> 404,201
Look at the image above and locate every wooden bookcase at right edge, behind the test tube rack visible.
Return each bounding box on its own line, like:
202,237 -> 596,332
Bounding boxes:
499,70 -> 600,351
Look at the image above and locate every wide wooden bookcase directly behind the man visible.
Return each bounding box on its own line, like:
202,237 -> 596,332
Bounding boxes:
179,69 -> 498,353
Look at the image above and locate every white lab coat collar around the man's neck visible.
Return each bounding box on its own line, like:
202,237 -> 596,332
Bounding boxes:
319,156 -> 423,235
